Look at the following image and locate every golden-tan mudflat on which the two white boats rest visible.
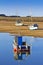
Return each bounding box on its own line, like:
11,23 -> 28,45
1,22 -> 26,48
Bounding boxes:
0,18 -> 43,37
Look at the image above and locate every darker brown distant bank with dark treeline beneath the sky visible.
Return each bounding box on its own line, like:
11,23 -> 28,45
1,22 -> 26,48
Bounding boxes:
0,15 -> 43,22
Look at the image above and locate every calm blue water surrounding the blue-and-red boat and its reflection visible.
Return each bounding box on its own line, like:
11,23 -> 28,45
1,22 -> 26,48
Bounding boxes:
0,33 -> 43,65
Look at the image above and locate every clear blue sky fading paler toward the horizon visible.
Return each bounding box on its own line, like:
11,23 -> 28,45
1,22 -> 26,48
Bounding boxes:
0,0 -> 43,16
